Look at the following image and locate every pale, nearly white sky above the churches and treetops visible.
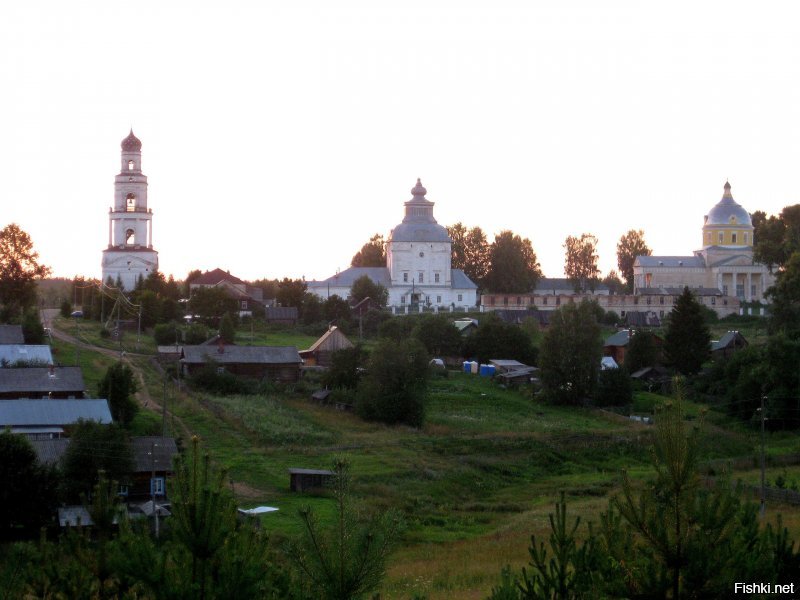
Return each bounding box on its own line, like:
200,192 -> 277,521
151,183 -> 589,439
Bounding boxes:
0,0 -> 800,279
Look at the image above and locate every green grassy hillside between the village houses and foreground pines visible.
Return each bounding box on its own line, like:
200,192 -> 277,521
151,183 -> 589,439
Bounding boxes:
50,330 -> 800,600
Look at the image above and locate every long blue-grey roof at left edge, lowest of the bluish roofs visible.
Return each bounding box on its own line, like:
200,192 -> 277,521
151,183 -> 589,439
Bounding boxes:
0,398 -> 111,427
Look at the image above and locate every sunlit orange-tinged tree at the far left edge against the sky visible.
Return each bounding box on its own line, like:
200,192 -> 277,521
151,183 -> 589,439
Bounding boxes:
0,223 -> 50,316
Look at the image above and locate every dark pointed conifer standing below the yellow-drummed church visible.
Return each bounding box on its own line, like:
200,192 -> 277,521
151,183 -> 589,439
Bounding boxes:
664,287 -> 711,375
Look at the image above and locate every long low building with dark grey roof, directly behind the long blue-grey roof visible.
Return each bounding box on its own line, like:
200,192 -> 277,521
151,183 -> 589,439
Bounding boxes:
0,366 -> 86,400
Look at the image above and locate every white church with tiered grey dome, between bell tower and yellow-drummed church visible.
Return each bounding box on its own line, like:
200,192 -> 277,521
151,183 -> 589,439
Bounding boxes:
306,179 -> 478,312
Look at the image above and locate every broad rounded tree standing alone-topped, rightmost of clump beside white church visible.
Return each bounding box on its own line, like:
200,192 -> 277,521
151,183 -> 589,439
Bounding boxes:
484,230 -> 542,294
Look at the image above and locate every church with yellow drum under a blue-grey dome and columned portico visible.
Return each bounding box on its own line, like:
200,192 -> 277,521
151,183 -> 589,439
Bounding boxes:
633,182 -> 775,302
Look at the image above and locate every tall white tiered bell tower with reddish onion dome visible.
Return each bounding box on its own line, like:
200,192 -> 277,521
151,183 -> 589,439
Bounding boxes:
103,129 -> 158,290
